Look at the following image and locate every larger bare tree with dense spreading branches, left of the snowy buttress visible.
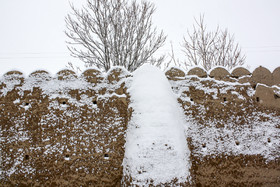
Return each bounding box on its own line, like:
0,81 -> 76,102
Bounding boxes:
65,0 -> 166,71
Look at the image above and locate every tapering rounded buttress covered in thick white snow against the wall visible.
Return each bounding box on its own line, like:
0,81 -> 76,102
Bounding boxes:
123,65 -> 190,185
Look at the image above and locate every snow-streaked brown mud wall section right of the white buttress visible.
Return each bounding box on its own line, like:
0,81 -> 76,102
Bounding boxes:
166,67 -> 280,186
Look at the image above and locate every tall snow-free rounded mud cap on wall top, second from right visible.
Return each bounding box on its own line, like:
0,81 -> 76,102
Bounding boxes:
252,66 -> 273,86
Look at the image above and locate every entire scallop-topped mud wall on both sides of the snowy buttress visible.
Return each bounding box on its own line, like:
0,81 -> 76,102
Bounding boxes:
0,67 -> 280,186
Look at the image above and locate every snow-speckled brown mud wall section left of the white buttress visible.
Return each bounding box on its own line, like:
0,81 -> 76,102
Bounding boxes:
0,68 -> 130,186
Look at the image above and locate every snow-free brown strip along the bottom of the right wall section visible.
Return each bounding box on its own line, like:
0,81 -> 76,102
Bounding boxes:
192,155 -> 280,186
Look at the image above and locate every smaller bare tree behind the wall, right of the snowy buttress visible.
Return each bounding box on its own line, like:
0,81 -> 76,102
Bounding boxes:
183,16 -> 245,70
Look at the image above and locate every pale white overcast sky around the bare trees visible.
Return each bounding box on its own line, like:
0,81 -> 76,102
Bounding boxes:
0,0 -> 280,75
